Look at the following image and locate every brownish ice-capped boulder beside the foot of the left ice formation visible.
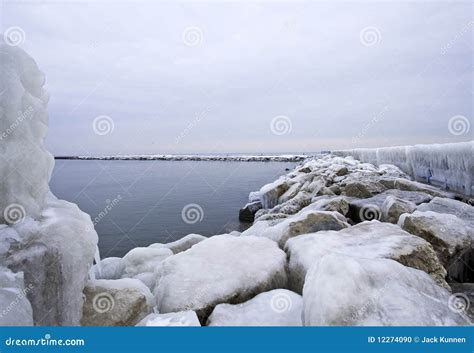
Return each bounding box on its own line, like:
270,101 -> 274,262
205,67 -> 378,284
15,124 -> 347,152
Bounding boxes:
81,278 -> 154,326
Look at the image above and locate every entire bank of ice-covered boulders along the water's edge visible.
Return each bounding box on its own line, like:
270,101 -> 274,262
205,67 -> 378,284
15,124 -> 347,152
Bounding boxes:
90,151 -> 474,326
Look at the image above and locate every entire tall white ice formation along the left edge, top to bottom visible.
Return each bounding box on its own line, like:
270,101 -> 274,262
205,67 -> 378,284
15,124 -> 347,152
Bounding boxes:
0,40 -> 97,325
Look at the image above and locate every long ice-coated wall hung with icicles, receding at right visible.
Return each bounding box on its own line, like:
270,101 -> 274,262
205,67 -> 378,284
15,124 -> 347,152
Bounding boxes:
333,141 -> 474,196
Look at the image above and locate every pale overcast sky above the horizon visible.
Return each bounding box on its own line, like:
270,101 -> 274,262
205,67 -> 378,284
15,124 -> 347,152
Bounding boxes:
2,0 -> 474,155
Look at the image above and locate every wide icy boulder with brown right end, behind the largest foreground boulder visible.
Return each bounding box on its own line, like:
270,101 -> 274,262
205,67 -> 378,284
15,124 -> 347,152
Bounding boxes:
285,221 -> 448,293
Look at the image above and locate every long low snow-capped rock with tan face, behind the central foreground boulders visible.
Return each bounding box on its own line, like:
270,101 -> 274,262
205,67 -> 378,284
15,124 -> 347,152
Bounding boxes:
242,208 -> 349,248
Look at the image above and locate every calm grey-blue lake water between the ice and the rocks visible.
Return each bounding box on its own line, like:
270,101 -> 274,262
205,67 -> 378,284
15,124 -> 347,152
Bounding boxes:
50,160 -> 296,258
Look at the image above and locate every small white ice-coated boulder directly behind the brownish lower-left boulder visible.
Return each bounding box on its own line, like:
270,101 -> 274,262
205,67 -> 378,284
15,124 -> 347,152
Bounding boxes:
123,247 -> 173,278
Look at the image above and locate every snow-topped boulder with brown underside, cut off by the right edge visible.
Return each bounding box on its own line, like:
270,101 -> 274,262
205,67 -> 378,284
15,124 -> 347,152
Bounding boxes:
399,211 -> 474,274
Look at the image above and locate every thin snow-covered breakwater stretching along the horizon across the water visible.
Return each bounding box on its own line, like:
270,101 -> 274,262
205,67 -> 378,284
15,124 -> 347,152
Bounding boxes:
56,154 -> 310,162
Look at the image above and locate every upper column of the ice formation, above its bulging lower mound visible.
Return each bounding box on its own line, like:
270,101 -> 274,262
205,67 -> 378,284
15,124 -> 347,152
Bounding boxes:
0,42 -> 54,223
